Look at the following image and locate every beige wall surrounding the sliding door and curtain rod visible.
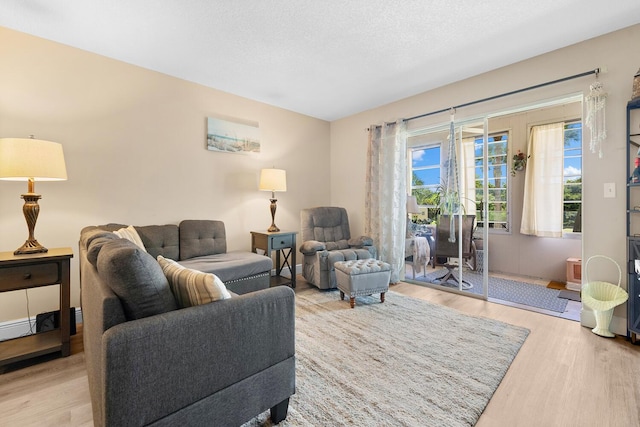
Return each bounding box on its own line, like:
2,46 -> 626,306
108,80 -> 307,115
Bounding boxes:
330,25 -> 640,333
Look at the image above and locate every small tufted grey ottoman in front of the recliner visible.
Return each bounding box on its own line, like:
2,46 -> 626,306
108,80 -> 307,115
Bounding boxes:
334,258 -> 391,308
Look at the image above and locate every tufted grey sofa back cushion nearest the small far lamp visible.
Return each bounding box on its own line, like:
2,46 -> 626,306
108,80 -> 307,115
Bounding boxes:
179,219 -> 227,260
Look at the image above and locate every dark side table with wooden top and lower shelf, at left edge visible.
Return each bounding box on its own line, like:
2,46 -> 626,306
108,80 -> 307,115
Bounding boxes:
0,248 -> 73,372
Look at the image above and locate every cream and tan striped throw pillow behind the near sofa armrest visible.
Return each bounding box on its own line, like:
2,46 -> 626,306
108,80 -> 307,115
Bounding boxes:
158,255 -> 231,308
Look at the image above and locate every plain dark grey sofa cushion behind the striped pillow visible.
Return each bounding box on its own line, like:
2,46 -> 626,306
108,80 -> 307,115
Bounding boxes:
96,239 -> 178,320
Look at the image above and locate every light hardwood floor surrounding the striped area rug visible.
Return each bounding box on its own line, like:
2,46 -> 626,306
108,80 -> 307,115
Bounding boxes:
0,276 -> 640,427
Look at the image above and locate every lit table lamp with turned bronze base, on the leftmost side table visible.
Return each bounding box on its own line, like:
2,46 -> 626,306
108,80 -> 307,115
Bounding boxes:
0,137 -> 67,255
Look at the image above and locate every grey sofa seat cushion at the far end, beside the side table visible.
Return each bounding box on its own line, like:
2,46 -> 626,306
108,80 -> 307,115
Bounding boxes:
180,251 -> 273,283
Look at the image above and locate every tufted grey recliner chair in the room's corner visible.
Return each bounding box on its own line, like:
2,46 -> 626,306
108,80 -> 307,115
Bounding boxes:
300,207 -> 377,289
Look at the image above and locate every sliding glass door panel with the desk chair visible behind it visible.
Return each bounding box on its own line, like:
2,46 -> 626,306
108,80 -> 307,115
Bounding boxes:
405,119 -> 490,299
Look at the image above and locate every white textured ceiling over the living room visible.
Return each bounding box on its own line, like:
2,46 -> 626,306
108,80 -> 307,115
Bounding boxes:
0,0 -> 640,120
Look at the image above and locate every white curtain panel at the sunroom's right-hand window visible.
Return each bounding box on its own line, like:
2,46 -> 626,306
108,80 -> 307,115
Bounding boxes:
520,123 -> 564,237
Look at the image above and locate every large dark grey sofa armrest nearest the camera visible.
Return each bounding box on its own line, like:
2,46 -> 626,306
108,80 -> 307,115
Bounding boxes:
102,286 -> 295,425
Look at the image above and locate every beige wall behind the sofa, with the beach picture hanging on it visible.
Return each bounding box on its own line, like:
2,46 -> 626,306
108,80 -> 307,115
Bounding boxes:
0,27 -> 330,322
